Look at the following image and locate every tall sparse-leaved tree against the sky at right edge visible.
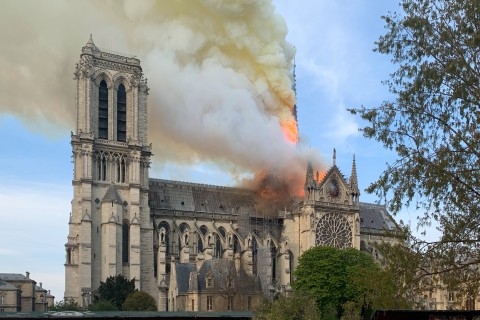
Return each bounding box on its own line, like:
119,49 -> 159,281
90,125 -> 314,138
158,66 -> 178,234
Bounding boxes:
350,0 -> 480,294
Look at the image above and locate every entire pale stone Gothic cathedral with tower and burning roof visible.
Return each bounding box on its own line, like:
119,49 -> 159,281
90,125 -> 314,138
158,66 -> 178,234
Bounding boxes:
64,37 -> 397,311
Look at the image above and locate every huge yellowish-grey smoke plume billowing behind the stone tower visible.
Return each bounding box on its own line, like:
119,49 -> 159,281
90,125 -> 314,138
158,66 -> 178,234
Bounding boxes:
0,0 -> 319,195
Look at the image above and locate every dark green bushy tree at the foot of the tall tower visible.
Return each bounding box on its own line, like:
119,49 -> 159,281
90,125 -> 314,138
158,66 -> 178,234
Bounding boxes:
94,274 -> 135,310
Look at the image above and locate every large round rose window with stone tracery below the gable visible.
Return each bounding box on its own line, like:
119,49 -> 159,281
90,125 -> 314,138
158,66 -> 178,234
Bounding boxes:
315,213 -> 352,248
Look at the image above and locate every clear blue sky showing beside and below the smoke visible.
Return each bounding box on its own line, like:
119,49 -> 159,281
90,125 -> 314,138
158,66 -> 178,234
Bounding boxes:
0,0 -> 432,301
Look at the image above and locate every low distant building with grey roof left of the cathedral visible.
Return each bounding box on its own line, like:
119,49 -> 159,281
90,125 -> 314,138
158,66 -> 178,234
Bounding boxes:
0,272 -> 55,312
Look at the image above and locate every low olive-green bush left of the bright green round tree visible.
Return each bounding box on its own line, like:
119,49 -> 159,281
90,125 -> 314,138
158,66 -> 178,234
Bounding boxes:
255,292 -> 319,320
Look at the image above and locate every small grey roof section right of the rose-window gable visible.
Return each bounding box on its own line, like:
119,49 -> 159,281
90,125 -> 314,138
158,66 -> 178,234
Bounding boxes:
360,202 -> 398,231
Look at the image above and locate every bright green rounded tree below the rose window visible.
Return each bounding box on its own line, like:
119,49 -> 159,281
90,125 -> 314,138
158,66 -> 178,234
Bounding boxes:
292,247 -> 383,318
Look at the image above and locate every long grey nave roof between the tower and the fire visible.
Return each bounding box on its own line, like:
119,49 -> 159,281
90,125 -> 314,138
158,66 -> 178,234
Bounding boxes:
149,179 -> 256,214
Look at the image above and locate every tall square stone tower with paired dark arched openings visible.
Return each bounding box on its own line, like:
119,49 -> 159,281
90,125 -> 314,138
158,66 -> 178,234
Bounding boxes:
65,36 -> 155,306
